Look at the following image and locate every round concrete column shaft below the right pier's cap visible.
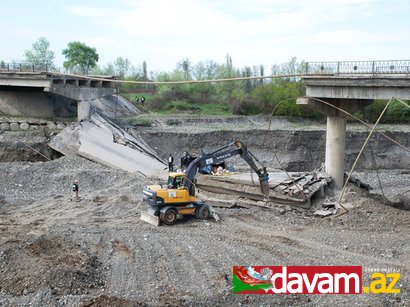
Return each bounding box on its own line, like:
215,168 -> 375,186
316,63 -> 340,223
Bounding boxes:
325,116 -> 346,190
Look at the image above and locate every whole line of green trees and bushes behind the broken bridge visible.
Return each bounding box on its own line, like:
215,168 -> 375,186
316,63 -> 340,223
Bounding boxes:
14,37 -> 410,122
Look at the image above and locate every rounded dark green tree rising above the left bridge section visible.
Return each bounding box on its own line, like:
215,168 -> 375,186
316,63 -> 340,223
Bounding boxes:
63,42 -> 98,74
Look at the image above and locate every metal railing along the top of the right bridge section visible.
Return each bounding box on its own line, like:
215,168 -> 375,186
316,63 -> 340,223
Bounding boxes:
305,60 -> 410,75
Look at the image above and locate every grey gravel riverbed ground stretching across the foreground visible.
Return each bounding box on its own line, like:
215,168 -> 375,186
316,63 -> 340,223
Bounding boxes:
0,157 -> 410,306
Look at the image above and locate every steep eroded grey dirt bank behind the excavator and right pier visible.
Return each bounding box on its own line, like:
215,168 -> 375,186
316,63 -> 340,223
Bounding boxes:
142,129 -> 410,171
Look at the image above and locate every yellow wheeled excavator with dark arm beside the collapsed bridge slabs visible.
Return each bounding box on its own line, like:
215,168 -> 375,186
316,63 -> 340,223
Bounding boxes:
141,141 -> 269,226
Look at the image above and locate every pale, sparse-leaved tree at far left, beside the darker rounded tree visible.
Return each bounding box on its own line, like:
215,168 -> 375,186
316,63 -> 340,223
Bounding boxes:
24,36 -> 55,70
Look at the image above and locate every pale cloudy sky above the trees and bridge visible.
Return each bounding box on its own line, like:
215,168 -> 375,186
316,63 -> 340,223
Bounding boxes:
0,0 -> 410,71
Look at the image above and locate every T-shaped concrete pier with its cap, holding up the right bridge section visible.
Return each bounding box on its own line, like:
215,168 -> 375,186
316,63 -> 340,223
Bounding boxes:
297,97 -> 373,190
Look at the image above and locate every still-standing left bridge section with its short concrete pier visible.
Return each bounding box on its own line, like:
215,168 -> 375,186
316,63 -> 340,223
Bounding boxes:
0,70 -> 118,120
